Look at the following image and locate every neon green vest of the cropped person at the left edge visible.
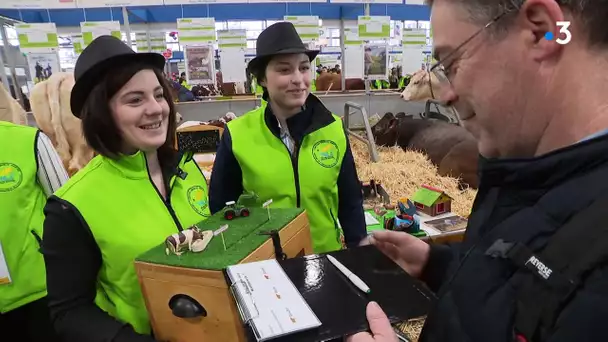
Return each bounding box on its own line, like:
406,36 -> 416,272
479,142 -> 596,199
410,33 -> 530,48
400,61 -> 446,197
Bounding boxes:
0,121 -> 46,313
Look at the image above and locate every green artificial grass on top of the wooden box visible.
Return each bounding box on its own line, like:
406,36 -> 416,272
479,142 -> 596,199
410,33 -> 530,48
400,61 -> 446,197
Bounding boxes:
137,207 -> 304,270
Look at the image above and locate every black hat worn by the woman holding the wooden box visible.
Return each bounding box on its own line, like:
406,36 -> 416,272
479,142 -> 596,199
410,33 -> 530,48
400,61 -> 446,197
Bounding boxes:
70,36 -> 165,117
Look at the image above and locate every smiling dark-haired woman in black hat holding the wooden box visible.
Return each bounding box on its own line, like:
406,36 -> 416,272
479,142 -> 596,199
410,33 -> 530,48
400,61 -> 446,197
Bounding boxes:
43,36 -> 209,342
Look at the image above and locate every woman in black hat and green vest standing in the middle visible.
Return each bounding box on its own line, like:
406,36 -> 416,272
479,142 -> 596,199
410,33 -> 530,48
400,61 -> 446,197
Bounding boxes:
209,22 -> 367,253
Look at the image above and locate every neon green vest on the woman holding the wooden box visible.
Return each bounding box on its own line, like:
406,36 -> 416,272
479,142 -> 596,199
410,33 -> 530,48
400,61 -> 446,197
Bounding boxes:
55,151 -> 211,334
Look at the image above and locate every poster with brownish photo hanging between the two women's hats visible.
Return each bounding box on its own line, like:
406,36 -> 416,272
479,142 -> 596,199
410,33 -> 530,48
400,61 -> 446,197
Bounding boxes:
184,45 -> 215,85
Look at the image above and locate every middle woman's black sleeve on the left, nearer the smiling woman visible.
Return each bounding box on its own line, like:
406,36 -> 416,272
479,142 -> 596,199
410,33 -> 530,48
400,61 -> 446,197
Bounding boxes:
209,126 -> 243,214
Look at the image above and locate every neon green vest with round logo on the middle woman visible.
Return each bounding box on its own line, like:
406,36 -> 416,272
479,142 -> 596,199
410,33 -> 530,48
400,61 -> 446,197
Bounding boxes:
228,100 -> 347,253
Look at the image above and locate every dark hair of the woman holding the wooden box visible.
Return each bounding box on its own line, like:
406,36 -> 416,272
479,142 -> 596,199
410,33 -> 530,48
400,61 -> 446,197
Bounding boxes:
80,64 -> 177,165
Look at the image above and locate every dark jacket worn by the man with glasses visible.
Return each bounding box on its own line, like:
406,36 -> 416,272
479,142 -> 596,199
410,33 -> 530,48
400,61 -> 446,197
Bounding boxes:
420,136 -> 608,342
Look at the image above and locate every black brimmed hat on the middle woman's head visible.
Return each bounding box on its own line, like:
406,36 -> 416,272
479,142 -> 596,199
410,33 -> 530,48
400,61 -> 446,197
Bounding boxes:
247,21 -> 319,72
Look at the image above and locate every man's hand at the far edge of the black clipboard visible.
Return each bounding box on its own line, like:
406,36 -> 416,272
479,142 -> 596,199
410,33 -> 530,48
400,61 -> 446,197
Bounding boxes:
370,230 -> 431,278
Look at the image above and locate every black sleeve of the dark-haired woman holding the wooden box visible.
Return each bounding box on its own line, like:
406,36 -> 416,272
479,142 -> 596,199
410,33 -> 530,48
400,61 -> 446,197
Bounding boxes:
42,197 -> 156,342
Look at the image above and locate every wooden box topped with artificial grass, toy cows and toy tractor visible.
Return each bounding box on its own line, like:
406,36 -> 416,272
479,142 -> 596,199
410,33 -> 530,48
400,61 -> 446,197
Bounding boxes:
135,194 -> 313,342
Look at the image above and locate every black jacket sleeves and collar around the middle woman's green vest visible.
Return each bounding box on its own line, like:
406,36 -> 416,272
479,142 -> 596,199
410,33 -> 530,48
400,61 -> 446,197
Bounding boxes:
209,95 -> 367,247
